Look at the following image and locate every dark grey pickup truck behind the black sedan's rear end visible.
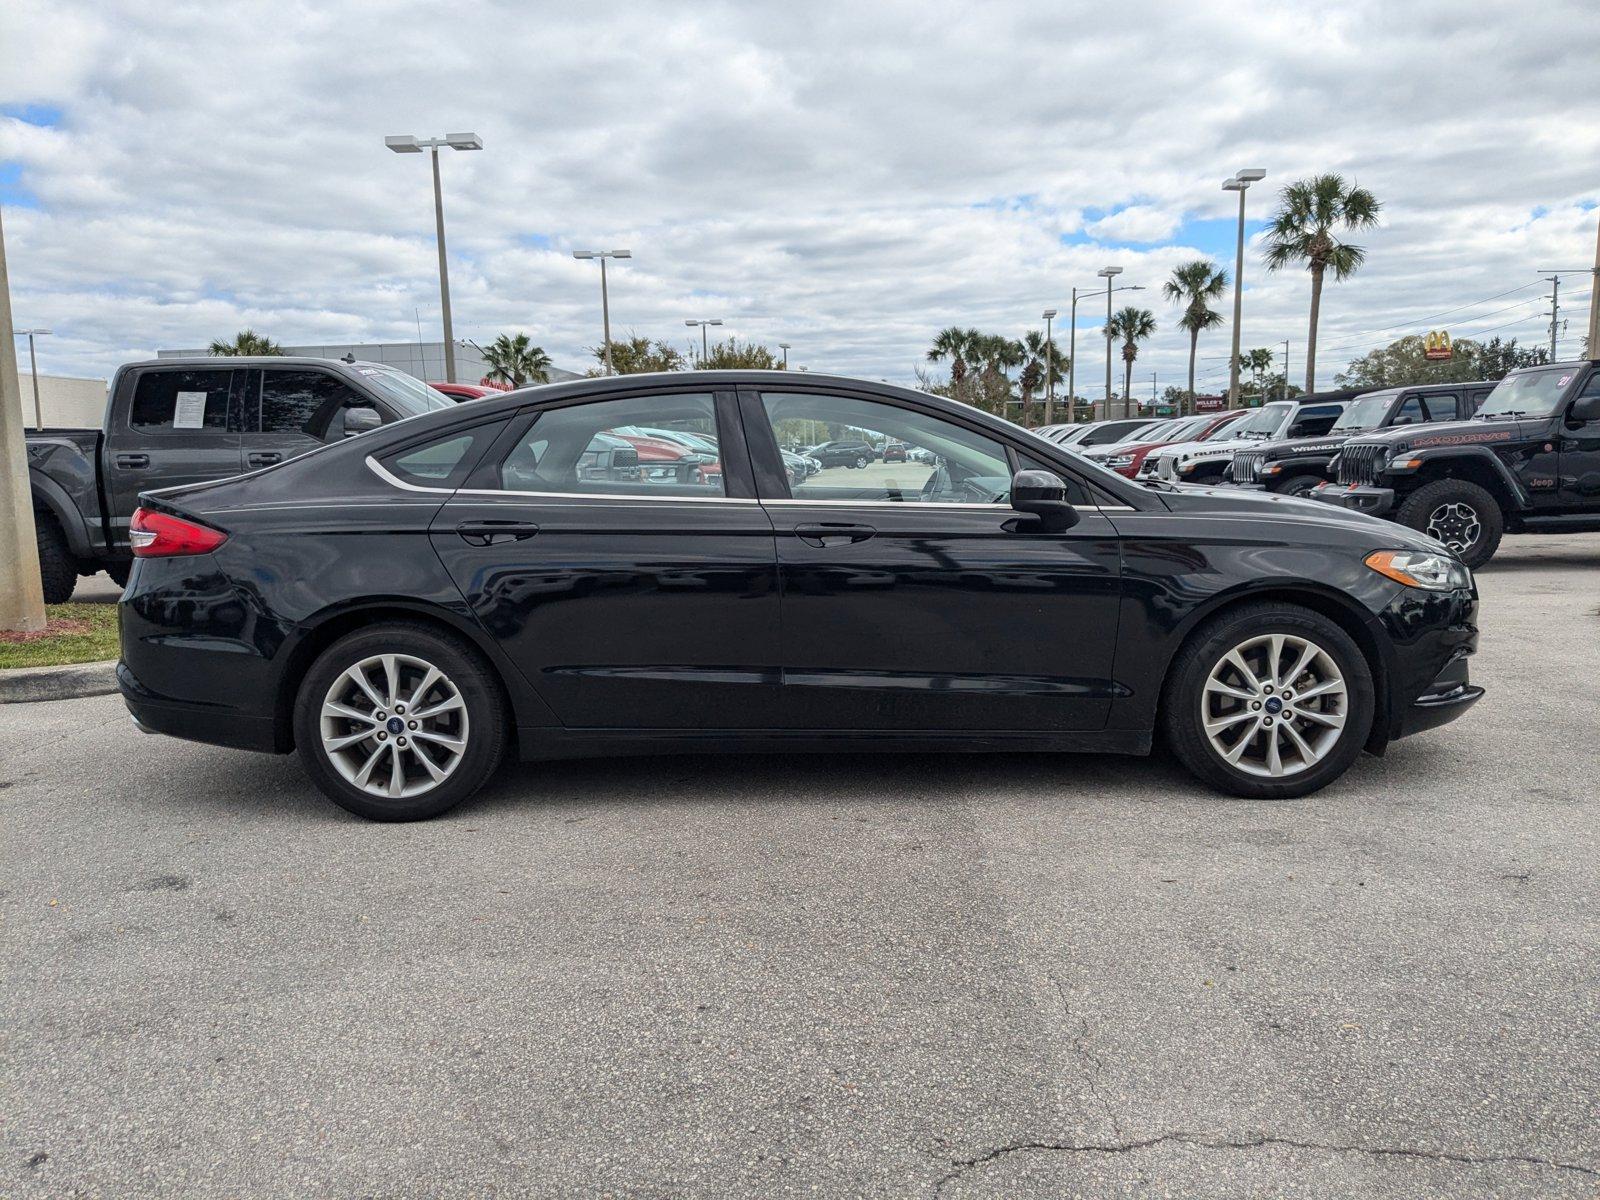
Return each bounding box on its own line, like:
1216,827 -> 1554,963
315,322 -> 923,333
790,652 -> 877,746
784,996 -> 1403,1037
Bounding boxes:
26,357 -> 454,605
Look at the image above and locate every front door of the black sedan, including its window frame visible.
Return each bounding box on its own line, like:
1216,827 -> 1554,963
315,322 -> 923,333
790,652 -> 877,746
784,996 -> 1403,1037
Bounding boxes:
739,387 -> 1120,733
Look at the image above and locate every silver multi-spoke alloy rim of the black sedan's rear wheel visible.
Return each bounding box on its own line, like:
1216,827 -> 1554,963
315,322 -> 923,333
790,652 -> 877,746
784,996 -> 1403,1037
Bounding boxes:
318,654 -> 467,800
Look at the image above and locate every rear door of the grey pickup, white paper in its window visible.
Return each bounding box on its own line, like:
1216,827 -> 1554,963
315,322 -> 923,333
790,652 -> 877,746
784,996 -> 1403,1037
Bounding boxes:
104,366 -> 245,546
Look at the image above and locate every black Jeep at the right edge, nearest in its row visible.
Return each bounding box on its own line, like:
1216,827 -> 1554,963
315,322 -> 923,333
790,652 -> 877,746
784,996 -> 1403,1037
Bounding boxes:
1310,358 -> 1600,568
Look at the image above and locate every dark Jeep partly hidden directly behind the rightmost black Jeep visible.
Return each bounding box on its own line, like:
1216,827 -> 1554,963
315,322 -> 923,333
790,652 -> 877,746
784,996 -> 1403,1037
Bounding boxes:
1222,382 -> 1494,496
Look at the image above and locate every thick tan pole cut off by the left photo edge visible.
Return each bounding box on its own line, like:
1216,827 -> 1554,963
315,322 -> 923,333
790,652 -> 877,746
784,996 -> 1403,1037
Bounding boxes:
0,204 -> 45,634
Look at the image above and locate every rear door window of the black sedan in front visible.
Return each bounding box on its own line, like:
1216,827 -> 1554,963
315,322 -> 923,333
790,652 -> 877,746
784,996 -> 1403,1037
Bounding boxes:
499,392 -> 726,498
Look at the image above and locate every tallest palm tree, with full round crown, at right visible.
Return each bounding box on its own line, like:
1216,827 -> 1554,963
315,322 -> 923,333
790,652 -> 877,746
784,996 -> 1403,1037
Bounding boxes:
1267,173 -> 1382,394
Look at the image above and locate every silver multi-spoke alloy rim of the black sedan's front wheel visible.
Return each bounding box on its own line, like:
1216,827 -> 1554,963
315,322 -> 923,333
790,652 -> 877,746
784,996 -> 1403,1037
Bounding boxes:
1200,634 -> 1349,779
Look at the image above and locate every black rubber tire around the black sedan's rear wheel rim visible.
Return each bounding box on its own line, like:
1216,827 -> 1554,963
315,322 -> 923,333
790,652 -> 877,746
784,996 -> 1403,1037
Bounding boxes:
294,621 -> 506,821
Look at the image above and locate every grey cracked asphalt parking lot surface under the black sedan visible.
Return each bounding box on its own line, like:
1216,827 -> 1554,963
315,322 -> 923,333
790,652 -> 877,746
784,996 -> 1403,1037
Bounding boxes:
0,534 -> 1600,1197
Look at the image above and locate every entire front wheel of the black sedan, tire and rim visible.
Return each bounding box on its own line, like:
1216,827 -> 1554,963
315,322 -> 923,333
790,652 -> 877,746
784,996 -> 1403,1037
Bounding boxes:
1163,603 -> 1374,800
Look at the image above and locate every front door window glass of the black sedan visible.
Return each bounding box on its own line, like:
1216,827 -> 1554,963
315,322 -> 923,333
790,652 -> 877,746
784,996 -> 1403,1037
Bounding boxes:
762,392 -> 1011,504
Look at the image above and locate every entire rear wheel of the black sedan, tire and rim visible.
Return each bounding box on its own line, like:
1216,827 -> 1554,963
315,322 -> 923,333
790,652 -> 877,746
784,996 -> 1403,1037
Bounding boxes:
294,622 -> 506,821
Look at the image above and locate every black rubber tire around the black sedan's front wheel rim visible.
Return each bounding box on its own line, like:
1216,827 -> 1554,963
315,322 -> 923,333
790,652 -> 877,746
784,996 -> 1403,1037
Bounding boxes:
1162,602 -> 1374,800
